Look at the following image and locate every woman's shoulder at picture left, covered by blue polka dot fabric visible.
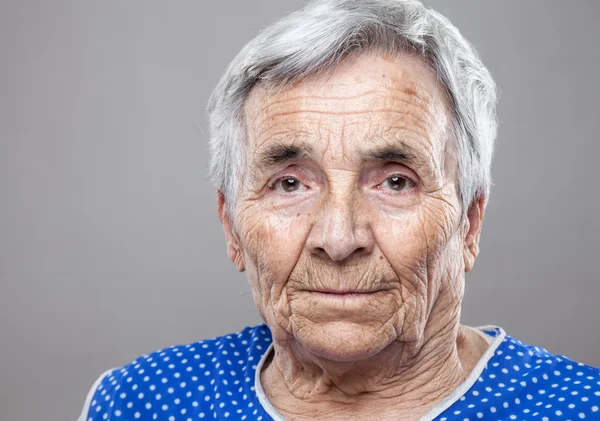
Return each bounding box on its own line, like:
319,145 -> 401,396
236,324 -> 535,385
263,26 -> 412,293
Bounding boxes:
80,325 -> 271,421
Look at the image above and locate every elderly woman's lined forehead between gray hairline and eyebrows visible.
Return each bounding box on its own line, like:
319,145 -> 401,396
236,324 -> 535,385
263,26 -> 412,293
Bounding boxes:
244,54 -> 449,166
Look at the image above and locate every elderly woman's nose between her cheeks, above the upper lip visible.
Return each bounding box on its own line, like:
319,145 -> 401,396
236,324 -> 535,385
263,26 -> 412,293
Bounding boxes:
307,190 -> 374,263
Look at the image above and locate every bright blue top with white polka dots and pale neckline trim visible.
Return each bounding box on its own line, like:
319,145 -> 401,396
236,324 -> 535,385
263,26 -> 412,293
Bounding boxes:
80,325 -> 600,421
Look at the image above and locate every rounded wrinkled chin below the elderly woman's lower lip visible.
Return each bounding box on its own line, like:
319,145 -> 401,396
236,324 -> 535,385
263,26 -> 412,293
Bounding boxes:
295,321 -> 396,362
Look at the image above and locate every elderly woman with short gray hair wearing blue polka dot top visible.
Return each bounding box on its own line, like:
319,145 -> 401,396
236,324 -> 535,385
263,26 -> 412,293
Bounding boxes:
81,0 -> 600,421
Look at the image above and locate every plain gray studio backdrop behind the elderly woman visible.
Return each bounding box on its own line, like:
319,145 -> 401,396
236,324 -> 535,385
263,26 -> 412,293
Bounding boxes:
0,0 -> 600,421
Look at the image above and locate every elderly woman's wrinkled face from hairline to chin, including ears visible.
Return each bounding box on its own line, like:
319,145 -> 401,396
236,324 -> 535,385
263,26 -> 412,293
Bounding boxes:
221,55 -> 476,361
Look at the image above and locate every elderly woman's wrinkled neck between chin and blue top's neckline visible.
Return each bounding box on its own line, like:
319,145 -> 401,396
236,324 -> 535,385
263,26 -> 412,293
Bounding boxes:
261,302 -> 487,420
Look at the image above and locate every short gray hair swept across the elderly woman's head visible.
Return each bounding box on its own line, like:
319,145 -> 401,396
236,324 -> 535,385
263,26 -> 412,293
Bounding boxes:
208,0 -> 497,216
